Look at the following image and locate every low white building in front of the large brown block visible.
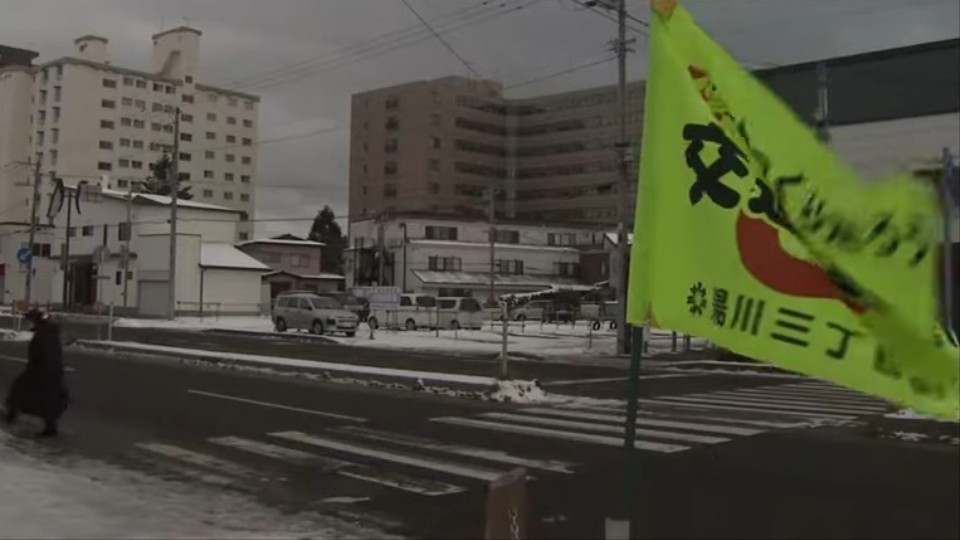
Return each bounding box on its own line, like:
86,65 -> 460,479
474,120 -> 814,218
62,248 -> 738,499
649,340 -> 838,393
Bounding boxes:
344,215 -> 604,299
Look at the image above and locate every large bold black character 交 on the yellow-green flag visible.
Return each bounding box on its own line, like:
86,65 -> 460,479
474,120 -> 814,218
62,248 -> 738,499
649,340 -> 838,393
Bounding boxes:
683,123 -> 748,208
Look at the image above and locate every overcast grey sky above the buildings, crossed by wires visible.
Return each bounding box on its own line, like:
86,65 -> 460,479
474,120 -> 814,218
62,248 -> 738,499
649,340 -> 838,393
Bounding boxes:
0,0 -> 960,234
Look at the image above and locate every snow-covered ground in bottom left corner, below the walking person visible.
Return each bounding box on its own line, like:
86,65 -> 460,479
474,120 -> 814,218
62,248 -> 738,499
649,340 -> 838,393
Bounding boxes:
0,433 -> 398,539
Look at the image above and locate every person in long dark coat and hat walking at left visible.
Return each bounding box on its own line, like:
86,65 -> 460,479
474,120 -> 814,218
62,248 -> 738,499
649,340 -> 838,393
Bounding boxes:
6,310 -> 67,437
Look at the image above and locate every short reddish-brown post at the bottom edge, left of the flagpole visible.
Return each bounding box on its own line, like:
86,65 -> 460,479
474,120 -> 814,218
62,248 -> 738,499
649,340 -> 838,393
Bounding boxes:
483,468 -> 529,540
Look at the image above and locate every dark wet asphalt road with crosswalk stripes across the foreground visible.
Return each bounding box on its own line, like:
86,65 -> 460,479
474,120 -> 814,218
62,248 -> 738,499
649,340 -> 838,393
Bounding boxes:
0,338 -> 960,538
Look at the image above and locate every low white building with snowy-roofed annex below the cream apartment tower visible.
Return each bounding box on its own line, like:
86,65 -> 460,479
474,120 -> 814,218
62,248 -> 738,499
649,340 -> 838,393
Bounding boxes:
0,181 -> 270,316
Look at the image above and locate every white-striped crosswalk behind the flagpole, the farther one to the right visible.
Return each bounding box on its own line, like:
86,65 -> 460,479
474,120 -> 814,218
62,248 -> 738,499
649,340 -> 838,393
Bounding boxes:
432,381 -> 891,454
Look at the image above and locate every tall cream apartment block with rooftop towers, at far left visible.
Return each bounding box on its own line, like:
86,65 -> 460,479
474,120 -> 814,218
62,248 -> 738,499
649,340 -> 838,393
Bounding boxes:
0,27 -> 259,240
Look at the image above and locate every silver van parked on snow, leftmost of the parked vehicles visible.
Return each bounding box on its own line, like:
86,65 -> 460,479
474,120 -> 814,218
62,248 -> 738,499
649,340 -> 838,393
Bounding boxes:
273,293 -> 359,337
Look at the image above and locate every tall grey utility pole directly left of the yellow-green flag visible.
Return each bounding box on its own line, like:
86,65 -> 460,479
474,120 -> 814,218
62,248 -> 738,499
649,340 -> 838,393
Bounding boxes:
614,0 -> 630,354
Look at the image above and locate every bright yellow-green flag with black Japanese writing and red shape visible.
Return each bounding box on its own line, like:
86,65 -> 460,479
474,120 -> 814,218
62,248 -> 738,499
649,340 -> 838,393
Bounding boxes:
629,0 -> 960,418
